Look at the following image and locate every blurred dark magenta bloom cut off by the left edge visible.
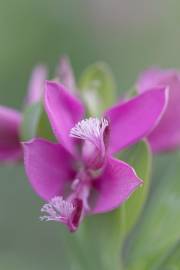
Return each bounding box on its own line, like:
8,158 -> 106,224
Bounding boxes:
0,106 -> 22,161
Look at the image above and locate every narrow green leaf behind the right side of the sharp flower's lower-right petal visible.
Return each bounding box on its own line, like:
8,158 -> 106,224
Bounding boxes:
119,141 -> 152,237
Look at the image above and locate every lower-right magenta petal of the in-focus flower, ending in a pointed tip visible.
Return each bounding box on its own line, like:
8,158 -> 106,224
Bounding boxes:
93,158 -> 143,214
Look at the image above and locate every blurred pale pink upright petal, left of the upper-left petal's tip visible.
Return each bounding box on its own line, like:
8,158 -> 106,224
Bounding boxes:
26,65 -> 47,105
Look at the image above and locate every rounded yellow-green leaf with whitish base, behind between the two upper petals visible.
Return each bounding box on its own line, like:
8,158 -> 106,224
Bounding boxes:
79,63 -> 116,116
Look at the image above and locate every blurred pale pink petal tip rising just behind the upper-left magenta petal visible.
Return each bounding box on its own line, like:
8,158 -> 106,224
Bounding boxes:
57,56 -> 76,94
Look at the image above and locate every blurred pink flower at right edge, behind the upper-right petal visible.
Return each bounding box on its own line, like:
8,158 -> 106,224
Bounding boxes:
137,68 -> 180,152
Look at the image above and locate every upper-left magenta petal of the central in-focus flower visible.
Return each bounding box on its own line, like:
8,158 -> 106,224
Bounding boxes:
45,81 -> 84,153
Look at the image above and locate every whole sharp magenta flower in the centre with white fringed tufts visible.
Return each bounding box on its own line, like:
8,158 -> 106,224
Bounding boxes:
24,81 -> 167,231
